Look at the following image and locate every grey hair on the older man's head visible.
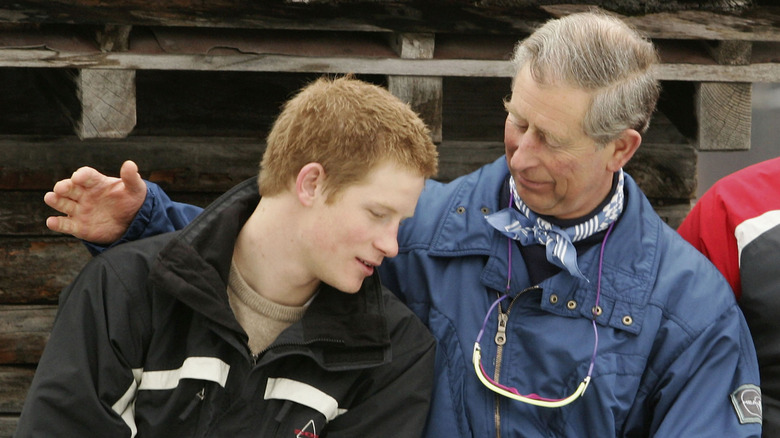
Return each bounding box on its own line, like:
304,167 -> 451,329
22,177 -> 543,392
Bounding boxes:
512,12 -> 660,145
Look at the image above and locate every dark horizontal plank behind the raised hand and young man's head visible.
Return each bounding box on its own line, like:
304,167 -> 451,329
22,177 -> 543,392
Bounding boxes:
0,137 -> 695,195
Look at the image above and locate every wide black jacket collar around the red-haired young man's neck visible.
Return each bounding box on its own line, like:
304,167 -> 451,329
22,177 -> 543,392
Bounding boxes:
150,178 -> 391,370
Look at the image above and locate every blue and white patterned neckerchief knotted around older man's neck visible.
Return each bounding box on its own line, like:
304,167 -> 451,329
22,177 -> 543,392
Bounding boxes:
485,169 -> 624,281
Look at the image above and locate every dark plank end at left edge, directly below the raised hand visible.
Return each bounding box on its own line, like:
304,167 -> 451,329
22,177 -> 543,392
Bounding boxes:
0,238 -> 91,304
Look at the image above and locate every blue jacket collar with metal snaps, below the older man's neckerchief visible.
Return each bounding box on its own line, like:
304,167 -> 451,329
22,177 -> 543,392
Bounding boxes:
414,157 -> 664,333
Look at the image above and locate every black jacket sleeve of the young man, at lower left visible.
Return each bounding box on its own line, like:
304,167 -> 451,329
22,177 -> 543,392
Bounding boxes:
15,253 -> 149,438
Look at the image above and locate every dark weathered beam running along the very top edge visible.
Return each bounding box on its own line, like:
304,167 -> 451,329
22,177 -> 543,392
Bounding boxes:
0,0 -> 777,40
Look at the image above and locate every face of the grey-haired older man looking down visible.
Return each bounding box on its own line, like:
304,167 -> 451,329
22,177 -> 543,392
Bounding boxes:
504,67 -> 613,219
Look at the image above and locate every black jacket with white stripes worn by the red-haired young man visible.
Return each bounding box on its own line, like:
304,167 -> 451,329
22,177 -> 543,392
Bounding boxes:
16,180 -> 434,438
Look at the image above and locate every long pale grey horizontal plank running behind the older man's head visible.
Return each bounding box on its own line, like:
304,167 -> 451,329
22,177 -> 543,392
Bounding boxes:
0,49 -> 780,82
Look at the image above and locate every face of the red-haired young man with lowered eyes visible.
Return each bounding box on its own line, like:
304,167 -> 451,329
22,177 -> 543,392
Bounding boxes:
309,163 -> 425,293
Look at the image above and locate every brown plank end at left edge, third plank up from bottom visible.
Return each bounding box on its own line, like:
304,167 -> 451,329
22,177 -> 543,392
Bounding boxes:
0,305 -> 57,364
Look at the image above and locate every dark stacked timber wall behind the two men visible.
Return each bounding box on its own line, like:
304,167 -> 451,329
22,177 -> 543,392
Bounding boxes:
0,0 -> 780,437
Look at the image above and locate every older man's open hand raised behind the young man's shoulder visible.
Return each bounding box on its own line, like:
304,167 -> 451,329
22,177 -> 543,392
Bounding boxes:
43,161 -> 146,245
